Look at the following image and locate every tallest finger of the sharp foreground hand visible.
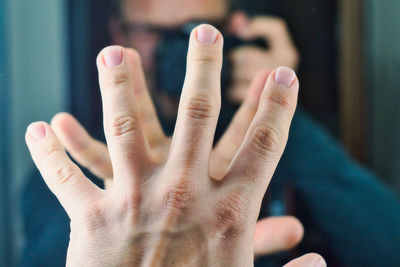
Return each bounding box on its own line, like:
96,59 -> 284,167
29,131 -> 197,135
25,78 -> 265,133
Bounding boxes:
170,24 -> 223,174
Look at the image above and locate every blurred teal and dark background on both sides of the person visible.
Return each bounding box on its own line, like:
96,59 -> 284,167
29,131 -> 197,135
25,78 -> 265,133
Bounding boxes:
0,0 -> 400,266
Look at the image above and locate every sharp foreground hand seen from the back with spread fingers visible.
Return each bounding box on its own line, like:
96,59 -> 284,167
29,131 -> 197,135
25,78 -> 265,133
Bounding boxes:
26,25 -> 324,266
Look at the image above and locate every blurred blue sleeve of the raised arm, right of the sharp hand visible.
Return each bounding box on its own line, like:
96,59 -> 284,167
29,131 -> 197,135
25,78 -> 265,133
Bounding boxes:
277,110 -> 400,266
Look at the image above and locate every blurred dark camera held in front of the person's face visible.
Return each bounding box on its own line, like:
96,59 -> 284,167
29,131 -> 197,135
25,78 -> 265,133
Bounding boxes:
155,23 -> 267,98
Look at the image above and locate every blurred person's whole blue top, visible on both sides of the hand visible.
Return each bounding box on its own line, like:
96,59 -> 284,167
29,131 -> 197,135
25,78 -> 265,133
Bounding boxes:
22,110 -> 400,266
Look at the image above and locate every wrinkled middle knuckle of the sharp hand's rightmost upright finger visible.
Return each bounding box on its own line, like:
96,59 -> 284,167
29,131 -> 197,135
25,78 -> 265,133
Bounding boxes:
252,126 -> 282,157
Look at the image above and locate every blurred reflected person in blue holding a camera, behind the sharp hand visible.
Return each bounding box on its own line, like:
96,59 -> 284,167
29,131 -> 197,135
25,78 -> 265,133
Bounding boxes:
24,0 -> 400,266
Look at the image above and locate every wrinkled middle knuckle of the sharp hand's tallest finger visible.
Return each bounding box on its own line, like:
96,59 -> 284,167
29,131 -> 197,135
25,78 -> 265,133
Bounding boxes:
187,96 -> 215,120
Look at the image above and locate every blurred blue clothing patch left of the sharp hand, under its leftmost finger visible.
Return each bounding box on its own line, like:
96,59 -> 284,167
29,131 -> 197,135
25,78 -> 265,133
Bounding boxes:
21,169 -> 69,267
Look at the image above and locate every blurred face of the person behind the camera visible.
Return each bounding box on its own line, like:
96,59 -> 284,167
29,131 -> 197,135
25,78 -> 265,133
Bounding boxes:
114,0 -> 227,71
